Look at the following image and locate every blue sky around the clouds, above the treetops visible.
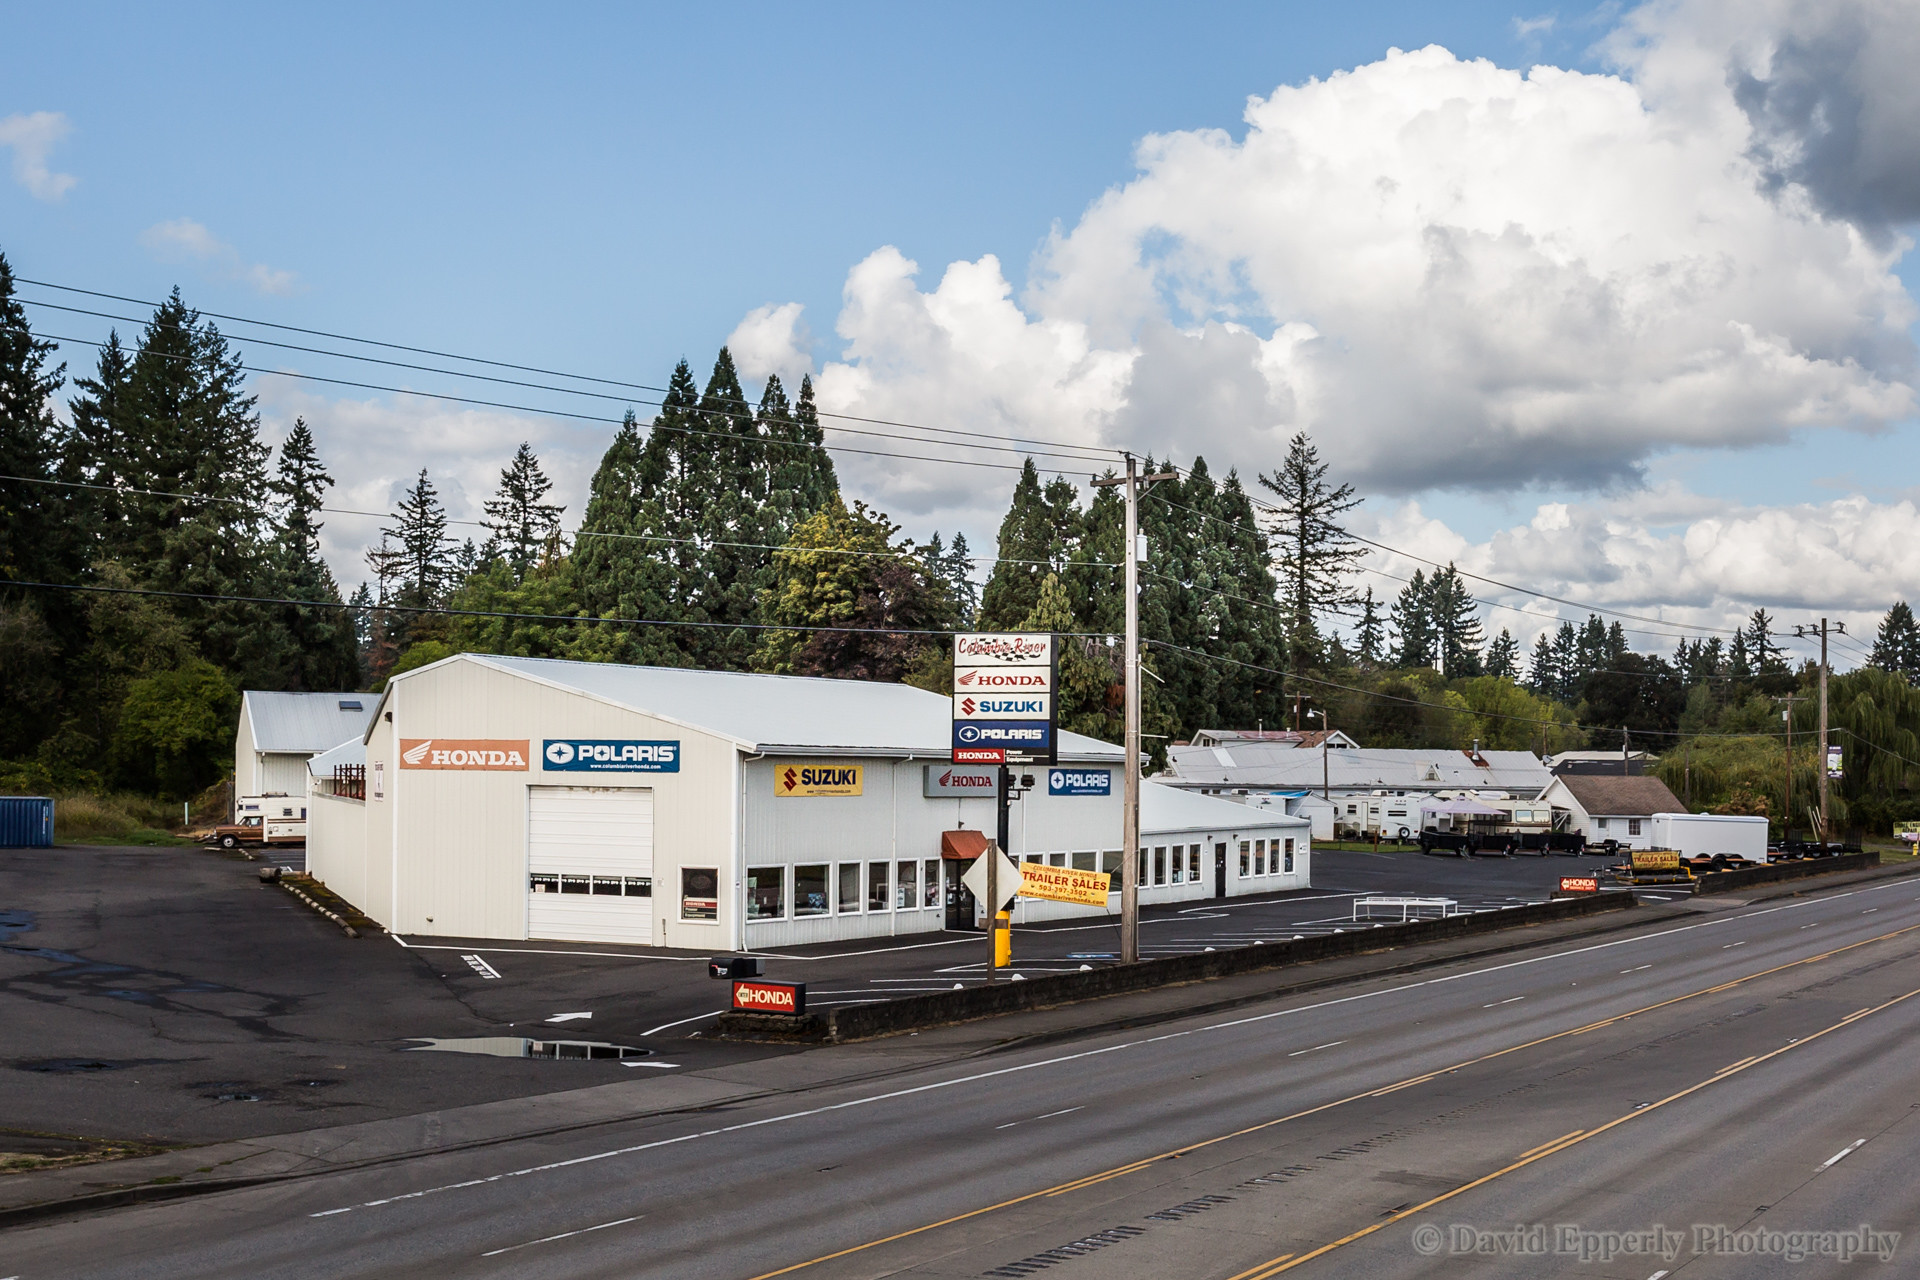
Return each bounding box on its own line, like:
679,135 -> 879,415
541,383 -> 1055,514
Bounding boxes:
0,0 -> 1920,660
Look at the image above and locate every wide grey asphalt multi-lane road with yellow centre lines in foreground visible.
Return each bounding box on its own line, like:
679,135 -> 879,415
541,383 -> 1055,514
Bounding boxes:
0,867 -> 1920,1280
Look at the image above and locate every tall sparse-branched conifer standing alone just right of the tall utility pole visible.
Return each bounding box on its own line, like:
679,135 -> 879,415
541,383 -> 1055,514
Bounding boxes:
1260,432 -> 1365,667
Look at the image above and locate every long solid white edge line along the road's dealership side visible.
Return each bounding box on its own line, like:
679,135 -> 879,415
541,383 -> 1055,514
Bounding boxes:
307,885 -> 1920,1219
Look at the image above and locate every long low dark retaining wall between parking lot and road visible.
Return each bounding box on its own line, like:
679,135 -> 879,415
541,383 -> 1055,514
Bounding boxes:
718,894 -> 1634,1044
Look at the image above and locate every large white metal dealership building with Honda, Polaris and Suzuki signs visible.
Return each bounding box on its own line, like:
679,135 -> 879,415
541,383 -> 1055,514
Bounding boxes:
307,654 -> 1309,950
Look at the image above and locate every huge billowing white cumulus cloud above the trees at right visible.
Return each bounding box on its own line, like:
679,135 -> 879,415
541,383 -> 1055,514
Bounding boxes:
743,0 -> 1920,510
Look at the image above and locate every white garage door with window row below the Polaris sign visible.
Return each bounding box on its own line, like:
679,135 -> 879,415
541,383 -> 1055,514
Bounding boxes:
526,787 -> 653,946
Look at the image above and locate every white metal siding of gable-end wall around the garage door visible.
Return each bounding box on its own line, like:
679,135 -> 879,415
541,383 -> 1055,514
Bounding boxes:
387,662 -> 737,950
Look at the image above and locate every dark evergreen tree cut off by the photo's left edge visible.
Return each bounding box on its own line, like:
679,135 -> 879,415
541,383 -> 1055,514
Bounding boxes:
0,253 -> 67,581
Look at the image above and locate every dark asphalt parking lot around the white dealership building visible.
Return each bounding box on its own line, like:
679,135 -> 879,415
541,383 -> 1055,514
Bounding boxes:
0,846 -> 1628,1150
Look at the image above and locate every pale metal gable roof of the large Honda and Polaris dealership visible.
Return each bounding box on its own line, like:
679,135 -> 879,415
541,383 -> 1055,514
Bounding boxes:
387,652 -> 1125,764
